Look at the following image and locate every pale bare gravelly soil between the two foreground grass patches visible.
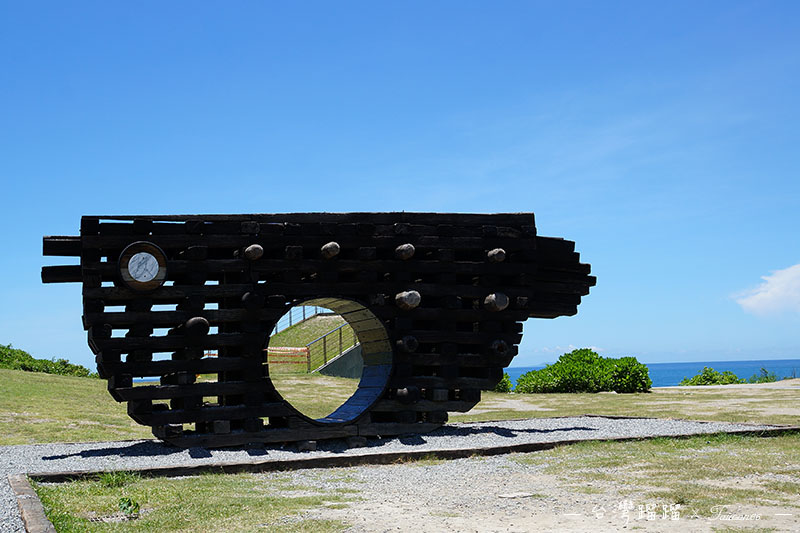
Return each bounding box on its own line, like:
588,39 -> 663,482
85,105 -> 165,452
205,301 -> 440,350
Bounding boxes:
296,456 -> 800,533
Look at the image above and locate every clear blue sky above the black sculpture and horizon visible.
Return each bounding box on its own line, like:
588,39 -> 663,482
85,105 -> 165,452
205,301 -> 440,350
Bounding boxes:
0,1 -> 800,366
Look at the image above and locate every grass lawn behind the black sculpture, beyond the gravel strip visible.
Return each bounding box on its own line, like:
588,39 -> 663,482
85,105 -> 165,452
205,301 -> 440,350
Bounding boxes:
0,369 -> 800,444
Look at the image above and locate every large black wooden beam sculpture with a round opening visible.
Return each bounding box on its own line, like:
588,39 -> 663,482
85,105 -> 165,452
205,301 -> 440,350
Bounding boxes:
42,213 -> 595,447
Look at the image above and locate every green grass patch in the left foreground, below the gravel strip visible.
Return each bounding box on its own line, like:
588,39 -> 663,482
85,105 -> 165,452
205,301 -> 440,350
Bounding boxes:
35,474 -> 355,533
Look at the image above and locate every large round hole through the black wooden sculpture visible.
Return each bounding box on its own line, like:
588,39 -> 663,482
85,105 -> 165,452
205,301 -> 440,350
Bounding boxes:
267,298 -> 392,423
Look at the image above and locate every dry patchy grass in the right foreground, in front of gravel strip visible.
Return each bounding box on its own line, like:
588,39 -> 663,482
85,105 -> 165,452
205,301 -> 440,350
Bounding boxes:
515,433 -> 800,516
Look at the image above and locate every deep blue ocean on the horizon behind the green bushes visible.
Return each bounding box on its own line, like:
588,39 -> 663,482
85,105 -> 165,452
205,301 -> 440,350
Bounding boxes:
506,359 -> 800,387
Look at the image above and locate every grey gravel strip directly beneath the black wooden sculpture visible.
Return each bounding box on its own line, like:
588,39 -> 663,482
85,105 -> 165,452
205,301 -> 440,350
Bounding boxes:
0,417 -> 788,533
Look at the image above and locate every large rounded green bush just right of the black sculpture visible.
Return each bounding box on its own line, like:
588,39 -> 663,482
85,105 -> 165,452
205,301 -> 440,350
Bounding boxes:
514,348 -> 653,393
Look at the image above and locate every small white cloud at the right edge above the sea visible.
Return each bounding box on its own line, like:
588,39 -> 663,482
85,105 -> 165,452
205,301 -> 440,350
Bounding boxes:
735,264 -> 800,315
